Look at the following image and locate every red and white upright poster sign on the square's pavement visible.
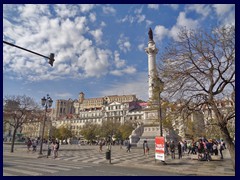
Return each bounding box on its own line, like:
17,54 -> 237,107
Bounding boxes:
155,137 -> 165,161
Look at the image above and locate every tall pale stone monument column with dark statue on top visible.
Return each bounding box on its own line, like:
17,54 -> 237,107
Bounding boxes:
145,28 -> 158,101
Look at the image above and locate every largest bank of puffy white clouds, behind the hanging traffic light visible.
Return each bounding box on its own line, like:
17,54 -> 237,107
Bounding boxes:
3,5 -> 141,81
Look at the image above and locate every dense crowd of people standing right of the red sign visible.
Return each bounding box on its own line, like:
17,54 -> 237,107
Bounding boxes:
165,139 -> 226,161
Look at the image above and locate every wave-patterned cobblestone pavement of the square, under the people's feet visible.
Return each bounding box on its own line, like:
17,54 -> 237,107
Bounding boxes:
4,145 -> 235,176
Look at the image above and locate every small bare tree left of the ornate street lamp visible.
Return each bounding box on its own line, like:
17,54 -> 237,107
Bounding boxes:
3,95 -> 41,152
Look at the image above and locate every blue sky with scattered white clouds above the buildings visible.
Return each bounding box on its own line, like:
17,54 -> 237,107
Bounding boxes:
3,4 -> 235,105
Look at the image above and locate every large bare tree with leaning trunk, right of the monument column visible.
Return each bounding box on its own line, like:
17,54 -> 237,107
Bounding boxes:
159,26 -> 235,168
